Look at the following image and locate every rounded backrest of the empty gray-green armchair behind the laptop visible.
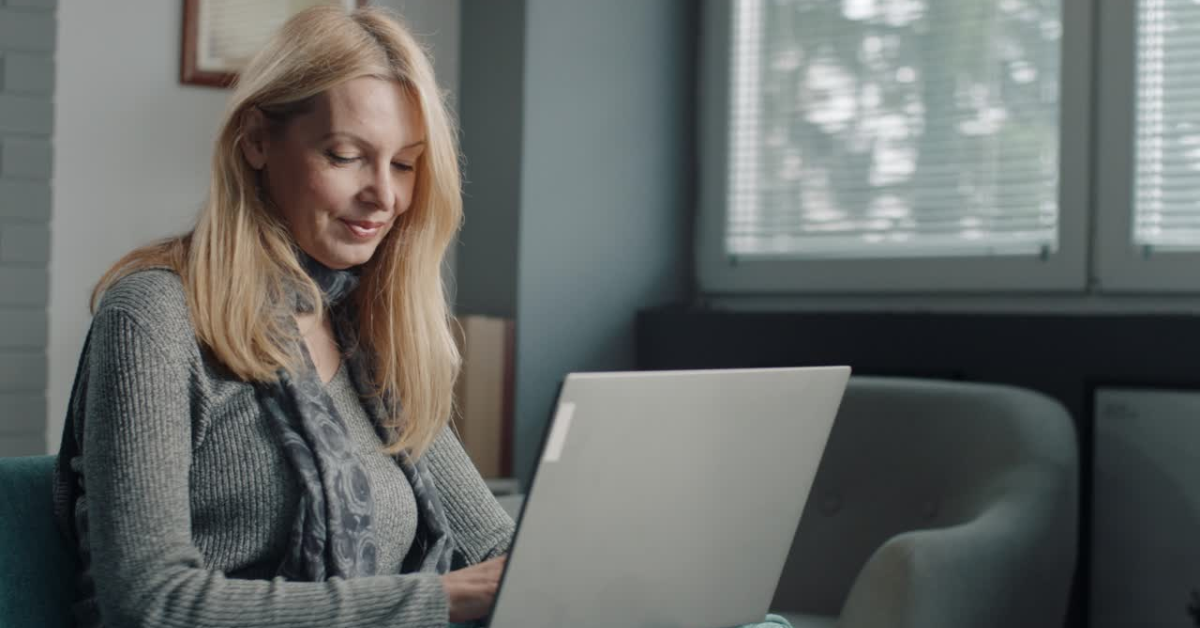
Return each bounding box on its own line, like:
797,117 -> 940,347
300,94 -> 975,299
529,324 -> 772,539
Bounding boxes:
772,377 -> 1078,616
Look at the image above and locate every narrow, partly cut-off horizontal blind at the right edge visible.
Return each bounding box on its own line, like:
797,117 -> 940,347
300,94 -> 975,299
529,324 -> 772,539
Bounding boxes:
1133,0 -> 1200,255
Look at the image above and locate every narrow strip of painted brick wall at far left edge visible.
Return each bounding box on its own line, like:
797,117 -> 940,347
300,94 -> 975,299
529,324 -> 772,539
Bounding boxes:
0,0 -> 58,456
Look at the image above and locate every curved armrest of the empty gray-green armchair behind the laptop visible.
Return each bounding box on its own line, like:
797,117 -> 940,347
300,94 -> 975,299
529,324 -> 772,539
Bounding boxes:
839,472 -> 1076,628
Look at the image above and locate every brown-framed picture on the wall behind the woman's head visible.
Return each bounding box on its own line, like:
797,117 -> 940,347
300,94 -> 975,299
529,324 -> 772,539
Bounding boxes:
179,0 -> 366,88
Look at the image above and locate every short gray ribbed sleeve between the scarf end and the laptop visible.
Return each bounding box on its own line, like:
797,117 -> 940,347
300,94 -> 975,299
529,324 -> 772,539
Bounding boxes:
425,427 -> 516,564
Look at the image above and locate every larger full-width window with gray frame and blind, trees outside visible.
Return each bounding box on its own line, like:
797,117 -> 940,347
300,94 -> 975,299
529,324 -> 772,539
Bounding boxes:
697,0 -> 1091,293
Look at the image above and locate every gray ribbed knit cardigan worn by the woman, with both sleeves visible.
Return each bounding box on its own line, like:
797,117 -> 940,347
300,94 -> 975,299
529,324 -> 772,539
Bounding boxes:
56,270 -> 514,628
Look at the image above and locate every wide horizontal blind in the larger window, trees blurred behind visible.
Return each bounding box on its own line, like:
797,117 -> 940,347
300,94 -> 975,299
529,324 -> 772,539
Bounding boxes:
725,0 -> 1065,259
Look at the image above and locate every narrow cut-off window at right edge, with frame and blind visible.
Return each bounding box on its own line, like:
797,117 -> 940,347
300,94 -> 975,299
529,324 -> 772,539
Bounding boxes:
1094,0 -> 1200,293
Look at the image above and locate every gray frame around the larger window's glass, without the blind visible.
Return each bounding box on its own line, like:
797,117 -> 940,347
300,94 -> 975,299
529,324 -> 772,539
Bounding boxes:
696,0 -> 1093,295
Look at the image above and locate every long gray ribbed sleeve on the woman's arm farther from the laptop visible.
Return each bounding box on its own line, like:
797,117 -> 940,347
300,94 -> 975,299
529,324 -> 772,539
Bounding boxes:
83,306 -> 451,628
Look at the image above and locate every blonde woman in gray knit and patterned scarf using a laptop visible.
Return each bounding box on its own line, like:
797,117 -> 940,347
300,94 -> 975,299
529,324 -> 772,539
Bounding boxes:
55,7 -> 514,628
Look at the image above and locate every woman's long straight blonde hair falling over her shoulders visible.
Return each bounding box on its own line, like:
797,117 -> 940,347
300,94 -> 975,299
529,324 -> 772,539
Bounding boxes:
91,6 -> 462,457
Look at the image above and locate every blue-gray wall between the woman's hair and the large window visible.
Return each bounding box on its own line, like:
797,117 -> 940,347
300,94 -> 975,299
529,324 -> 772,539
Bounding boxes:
458,0 -> 694,482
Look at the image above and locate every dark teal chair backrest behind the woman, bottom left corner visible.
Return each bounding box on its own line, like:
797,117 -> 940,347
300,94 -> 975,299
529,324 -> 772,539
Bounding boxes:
0,456 -> 76,628
